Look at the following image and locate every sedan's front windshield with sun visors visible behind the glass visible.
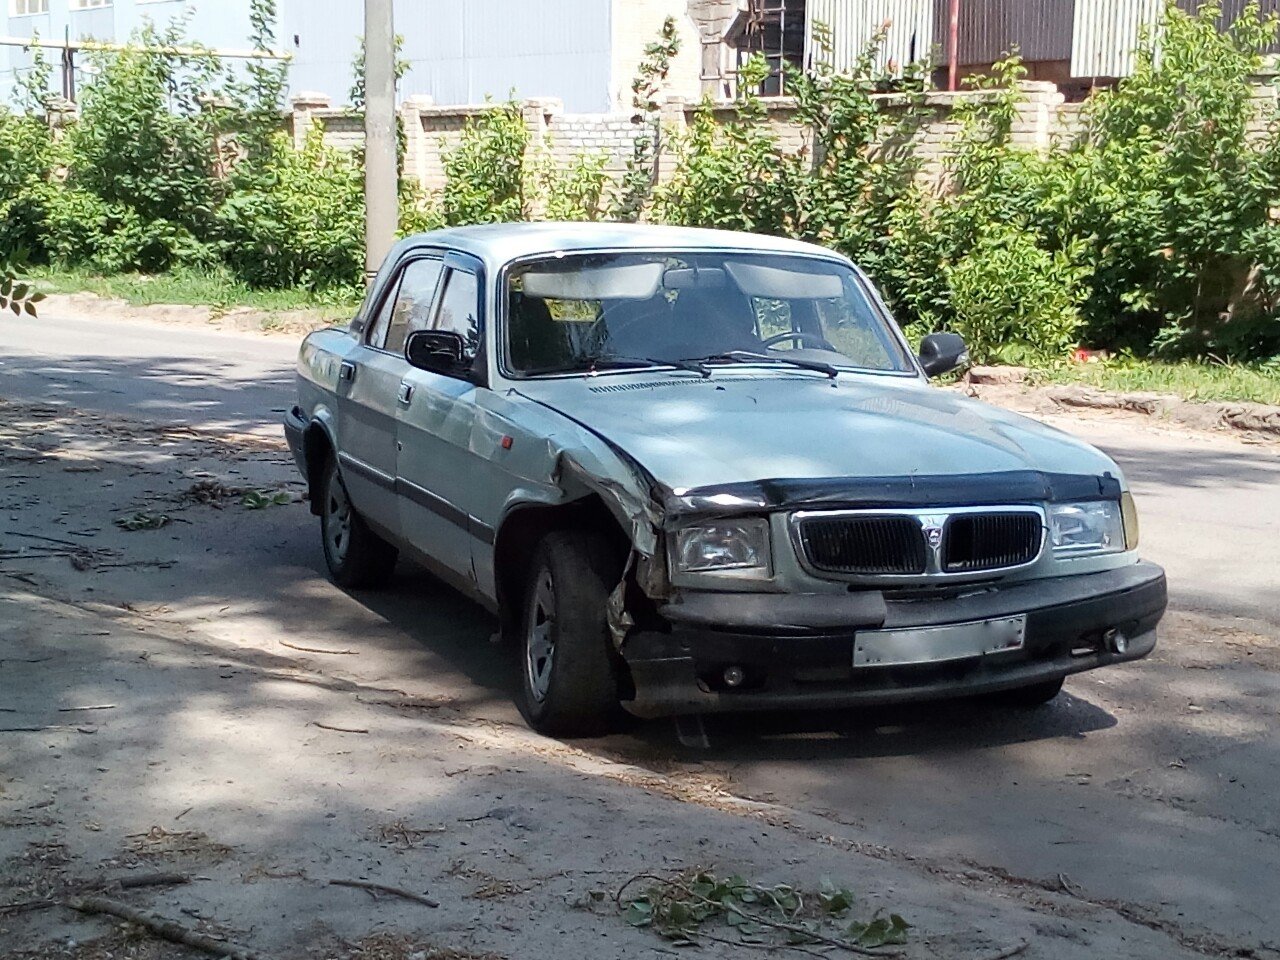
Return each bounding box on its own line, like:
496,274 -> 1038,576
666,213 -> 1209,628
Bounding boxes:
506,252 -> 914,376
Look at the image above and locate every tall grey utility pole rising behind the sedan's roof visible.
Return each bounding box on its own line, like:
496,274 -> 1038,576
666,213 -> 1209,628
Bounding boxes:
365,0 -> 399,279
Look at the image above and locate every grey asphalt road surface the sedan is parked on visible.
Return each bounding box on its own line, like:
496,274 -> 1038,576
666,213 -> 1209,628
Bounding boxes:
0,317 -> 1280,956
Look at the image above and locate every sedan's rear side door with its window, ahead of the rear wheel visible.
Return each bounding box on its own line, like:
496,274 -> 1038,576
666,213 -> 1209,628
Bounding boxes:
338,256 -> 443,536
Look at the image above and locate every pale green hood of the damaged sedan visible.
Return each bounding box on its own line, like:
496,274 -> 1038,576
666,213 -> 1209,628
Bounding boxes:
518,370 -> 1120,493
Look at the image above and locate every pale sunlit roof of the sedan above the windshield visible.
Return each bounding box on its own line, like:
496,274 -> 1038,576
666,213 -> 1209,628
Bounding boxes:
396,221 -> 847,268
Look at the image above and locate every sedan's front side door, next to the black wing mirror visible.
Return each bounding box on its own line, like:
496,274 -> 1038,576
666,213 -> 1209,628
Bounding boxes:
397,253 -> 489,582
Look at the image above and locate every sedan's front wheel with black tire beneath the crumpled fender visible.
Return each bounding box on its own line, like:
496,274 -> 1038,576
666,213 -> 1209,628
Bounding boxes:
520,530 -> 621,737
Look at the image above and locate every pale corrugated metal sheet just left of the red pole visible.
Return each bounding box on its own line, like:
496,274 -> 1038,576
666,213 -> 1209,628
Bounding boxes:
805,0 -> 936,73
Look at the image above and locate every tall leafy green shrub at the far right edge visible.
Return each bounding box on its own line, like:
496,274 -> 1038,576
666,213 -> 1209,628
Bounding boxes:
1062,3 -> 1280,353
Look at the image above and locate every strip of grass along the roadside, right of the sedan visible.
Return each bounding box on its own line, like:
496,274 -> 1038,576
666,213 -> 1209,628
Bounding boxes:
1033,358 -> 1280,404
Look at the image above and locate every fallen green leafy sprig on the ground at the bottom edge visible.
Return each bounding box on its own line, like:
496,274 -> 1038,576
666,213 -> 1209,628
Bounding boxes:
616,870 -> 910,952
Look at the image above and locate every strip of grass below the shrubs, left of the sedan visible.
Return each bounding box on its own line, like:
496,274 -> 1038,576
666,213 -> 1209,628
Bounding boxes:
24,266 -> 360,319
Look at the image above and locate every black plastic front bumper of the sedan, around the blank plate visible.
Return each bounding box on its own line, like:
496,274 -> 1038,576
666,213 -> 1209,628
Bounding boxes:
622,563 -> 1167,717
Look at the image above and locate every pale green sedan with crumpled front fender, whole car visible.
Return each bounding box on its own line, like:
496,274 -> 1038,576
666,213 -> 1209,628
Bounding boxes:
285,224 -> 1166,736
